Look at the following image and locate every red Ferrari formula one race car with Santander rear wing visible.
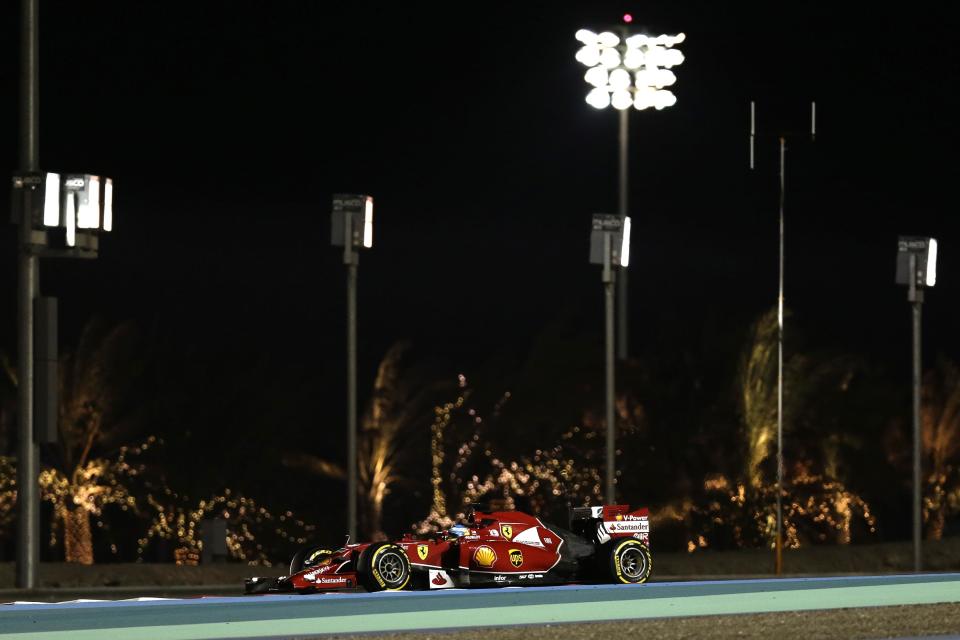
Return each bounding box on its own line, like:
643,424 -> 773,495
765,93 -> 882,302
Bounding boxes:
245,505 -> 652,593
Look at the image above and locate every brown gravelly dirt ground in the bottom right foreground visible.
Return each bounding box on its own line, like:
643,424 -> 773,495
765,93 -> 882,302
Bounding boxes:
323,604 -> 960,640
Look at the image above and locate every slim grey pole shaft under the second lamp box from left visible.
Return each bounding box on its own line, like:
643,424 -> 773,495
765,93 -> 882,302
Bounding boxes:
343,238 -> 359,541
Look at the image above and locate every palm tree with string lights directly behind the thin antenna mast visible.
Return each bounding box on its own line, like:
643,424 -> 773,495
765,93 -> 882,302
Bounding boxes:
736,309 -> 874,546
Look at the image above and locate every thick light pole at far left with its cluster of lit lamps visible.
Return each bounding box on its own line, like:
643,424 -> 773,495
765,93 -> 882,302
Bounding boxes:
11,0 -> 113,589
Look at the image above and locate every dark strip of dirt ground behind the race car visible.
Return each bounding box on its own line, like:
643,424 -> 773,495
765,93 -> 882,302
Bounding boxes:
0,537 -> 960,589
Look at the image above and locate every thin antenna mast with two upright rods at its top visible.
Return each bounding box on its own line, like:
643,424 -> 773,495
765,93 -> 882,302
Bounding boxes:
750,101 -> 817,576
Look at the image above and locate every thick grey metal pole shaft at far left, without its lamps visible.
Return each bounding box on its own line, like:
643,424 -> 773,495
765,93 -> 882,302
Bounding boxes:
16,0 -> 40,589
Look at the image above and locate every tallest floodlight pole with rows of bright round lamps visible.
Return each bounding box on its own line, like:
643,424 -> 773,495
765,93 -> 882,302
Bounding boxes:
576,20 -> 686,360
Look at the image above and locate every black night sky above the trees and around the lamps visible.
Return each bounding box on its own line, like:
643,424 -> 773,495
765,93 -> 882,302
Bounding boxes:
0,0 -> 960,540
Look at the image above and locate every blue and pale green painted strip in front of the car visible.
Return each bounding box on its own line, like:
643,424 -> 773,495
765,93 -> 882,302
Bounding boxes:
0,573 -> 960,640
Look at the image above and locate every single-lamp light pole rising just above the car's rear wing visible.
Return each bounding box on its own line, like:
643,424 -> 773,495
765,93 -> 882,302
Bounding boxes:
590,213 -> 630,504
